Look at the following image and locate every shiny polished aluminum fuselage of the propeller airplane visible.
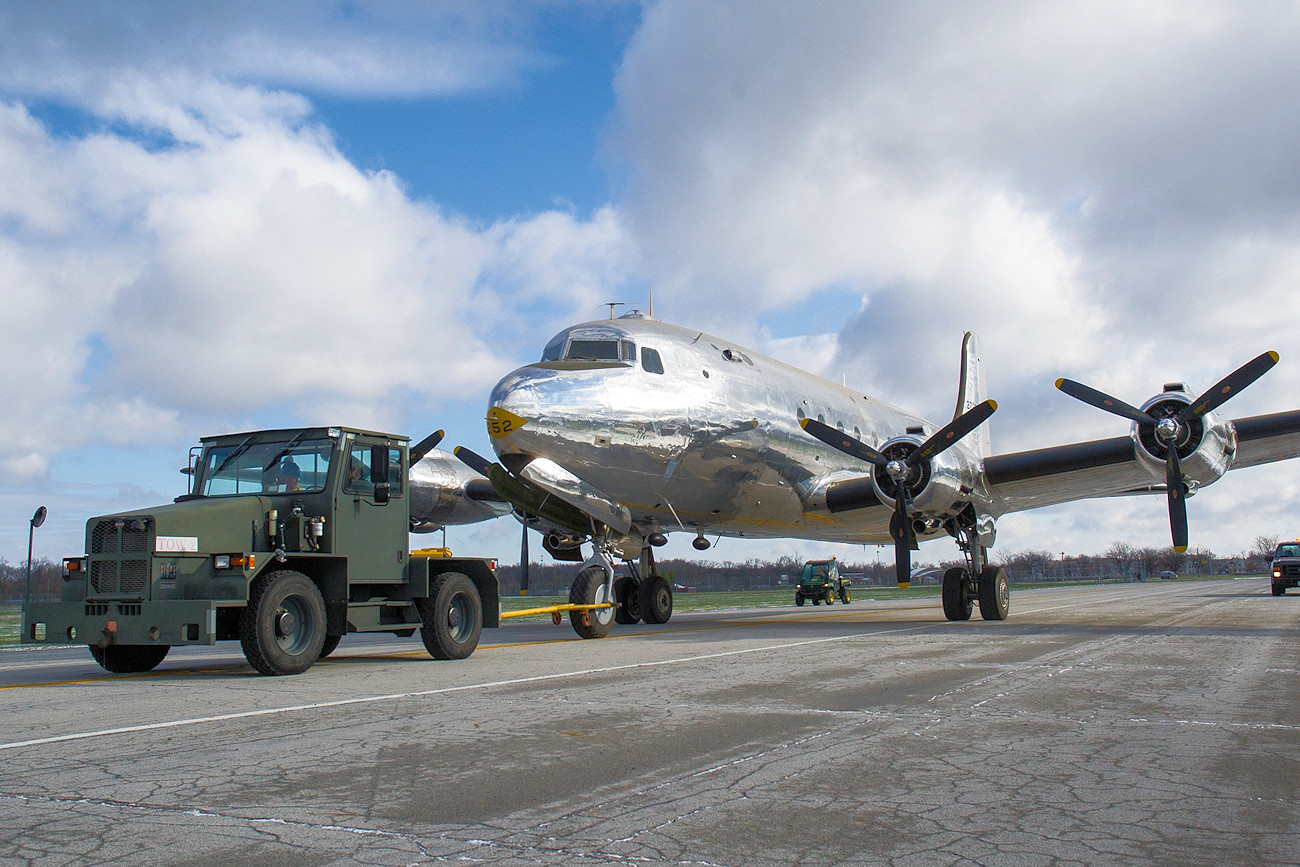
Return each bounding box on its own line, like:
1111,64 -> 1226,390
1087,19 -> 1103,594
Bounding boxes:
490,317 -> 982,543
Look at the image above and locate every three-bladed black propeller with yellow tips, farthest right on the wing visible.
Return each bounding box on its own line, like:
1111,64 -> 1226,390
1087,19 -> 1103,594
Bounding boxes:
1056,350 -> 1278,554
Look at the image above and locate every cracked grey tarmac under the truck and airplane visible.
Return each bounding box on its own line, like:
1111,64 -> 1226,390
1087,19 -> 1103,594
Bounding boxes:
0,580 -> 1300,867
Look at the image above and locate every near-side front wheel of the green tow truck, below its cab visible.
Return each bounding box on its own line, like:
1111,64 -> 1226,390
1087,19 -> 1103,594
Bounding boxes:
239,571 -> 325,675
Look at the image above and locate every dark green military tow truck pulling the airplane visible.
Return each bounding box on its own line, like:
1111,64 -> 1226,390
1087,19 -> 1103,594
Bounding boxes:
22,426 -> 501,675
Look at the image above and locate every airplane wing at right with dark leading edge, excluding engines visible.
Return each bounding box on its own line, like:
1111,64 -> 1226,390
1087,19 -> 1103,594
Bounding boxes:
984,411 -> 1300,512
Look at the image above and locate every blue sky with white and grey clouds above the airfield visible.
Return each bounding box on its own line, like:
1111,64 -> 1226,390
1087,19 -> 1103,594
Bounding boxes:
0,0 -> 1300,577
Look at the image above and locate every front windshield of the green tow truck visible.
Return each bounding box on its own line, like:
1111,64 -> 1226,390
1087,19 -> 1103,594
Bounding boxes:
196,432 -> 334,497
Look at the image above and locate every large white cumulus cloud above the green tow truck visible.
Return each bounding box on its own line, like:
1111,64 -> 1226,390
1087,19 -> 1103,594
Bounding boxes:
0,75 -> 628,488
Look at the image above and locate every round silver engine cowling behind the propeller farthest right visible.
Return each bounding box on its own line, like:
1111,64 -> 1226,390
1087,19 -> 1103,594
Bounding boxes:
1131,382 -> 1236,494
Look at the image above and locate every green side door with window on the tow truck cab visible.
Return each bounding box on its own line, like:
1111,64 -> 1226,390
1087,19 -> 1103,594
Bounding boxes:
334,437 -> 410,582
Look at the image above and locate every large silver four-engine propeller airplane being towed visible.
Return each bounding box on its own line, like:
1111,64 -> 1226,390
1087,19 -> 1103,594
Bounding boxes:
455,307 -> 1300,638
